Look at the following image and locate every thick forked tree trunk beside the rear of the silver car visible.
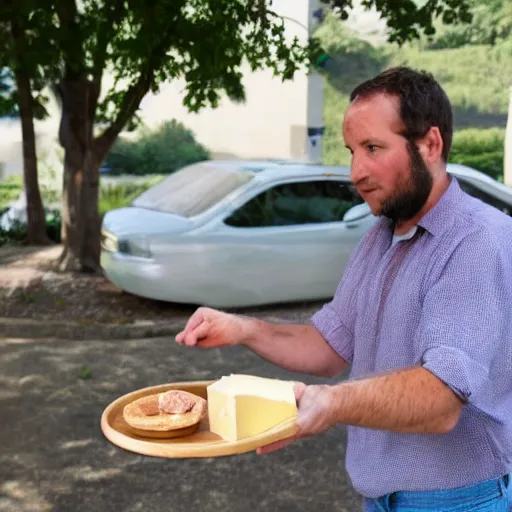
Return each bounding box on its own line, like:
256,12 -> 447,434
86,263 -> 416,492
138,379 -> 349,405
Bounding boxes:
57,60 -> 152,272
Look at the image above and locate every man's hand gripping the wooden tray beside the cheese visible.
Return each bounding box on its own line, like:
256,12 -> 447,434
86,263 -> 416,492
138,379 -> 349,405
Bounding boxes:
256,382 -> 336,455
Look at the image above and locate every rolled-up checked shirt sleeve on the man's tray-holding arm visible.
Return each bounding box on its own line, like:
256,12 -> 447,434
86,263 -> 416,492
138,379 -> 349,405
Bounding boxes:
414,232 -> 512,410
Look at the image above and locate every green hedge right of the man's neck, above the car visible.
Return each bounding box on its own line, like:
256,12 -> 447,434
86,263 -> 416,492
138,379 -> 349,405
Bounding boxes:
450,128 -> 505,181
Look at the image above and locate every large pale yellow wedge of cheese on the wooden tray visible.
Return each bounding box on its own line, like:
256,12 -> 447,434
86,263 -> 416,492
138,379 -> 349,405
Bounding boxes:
206,374 -> 297,441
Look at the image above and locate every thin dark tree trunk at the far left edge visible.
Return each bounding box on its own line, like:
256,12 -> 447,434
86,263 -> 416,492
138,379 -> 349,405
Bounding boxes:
11,35 -> 50,245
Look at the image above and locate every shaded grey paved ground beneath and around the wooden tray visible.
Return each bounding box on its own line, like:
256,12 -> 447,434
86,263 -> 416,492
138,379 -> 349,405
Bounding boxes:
0,339 -> 360,512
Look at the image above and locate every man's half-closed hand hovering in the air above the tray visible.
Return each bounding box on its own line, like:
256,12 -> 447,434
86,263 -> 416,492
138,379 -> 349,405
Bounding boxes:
176,308 -> 249,348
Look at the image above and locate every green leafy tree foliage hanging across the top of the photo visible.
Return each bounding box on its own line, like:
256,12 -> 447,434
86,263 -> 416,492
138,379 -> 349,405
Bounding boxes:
0,0 -> 478,144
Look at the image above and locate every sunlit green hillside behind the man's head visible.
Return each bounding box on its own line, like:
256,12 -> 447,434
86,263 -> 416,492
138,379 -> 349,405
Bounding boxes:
317,11 -> 512,178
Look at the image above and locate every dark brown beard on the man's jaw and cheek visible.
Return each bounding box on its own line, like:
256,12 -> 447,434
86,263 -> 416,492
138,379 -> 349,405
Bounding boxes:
381,141 -> 433,224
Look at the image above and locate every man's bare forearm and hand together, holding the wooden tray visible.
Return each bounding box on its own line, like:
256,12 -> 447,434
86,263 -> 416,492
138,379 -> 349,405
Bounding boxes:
257,366 -> 465,453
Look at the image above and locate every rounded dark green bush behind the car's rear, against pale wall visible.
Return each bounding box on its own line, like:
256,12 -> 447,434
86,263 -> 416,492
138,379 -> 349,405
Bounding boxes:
107,120 -> 209,175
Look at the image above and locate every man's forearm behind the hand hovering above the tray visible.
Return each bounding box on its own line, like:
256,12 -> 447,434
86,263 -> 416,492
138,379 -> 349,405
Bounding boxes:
241,318 -> 347,377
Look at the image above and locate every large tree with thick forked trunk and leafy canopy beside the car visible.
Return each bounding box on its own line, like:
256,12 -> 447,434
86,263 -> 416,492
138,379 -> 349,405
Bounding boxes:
0,0 -> 468,271
